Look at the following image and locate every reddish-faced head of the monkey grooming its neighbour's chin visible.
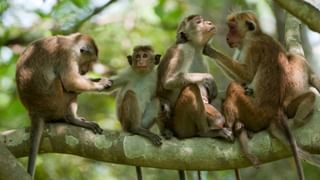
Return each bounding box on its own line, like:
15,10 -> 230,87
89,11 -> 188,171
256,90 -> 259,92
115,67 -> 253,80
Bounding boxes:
226,11 -> 261,48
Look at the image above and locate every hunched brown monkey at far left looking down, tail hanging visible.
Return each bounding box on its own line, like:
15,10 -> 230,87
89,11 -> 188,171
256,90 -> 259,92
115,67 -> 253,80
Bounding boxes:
16,33 -> 111,176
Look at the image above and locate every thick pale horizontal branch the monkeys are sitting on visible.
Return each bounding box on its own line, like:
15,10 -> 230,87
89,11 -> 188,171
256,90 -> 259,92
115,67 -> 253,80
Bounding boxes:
0,98 -> 320,170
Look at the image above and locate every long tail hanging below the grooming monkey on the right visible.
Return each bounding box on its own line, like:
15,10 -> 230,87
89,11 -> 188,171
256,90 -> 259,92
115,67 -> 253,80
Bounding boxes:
279,110 -> 304,180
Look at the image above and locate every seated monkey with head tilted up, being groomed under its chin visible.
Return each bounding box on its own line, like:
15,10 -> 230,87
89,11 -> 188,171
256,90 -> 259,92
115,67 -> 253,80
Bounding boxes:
157,15 -> 233,140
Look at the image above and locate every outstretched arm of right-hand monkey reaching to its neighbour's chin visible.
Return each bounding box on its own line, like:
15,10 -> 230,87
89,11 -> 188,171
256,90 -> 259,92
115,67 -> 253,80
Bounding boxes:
204,45 -> 253,83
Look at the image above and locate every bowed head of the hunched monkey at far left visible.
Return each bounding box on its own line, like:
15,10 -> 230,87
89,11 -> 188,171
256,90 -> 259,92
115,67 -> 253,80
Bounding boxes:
69,33 -> 98,75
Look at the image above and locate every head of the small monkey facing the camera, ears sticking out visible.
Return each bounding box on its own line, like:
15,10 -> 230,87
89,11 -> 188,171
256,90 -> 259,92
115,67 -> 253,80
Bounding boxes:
127,46 -> 161,73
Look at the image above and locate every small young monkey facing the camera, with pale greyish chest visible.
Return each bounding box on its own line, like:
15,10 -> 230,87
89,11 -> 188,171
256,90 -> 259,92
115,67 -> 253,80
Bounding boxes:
109,46 -> 162,180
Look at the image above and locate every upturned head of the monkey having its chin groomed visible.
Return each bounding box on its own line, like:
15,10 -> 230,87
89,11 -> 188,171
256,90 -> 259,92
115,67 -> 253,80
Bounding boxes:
177,15 -> 216,46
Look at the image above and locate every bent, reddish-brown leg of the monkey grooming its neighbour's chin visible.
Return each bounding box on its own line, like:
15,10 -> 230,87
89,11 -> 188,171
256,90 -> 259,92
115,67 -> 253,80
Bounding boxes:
223,82 -> 276,132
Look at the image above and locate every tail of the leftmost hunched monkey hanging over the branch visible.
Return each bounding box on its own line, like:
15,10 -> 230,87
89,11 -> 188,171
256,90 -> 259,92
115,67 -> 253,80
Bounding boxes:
28,117 -> 44,177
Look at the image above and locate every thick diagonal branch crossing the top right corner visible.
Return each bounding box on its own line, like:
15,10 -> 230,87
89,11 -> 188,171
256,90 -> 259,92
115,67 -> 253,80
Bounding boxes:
274,0 -> 320,32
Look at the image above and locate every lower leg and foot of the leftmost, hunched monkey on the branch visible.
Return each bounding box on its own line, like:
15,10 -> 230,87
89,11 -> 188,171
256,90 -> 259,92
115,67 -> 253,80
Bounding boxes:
65,98 -> 103,134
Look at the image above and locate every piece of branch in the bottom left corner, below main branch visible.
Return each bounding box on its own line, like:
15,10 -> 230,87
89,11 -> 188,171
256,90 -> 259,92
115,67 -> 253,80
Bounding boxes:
0,142 -> 31,180
